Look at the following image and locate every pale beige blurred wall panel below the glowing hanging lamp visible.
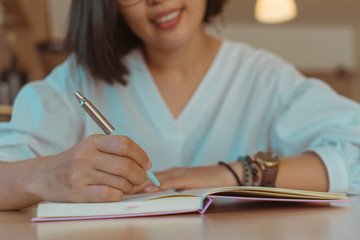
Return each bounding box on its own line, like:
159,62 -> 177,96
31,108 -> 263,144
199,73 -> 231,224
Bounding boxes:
208,23 -> 356,71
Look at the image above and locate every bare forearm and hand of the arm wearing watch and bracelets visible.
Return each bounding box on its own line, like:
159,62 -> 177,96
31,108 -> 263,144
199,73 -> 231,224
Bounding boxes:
136,153 -> 329,192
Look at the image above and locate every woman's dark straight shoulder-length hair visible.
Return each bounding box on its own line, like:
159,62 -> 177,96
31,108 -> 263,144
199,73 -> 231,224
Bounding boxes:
65,0 -> 227,85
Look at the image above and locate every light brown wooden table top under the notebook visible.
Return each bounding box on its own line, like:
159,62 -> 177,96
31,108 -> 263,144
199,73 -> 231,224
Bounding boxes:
0,196 -> 360,240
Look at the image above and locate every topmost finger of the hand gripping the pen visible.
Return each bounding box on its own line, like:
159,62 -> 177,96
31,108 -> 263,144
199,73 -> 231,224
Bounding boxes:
94,135 -> 152,170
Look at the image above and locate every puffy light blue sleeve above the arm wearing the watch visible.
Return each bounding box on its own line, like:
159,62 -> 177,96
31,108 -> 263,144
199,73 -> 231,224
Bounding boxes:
271,69 -> 360,194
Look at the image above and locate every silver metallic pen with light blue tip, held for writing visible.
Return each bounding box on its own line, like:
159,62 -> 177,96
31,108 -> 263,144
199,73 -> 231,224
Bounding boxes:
74,91 -> 161,189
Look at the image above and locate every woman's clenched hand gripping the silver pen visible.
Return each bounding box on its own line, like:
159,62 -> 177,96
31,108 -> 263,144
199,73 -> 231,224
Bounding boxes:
29,135 -> 151,202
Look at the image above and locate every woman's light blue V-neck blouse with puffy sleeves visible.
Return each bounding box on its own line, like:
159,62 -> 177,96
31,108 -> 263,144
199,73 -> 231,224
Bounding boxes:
0,41 -> 360,194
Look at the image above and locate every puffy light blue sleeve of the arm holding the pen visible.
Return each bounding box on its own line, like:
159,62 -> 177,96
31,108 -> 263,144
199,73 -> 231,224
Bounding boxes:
0,81 -> 82,161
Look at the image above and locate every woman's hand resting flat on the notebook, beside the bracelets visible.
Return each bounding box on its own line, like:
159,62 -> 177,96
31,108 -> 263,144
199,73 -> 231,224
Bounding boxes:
132,163 -> 241,193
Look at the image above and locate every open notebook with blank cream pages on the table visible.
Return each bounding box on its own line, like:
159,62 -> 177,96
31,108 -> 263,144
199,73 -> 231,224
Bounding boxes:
32,187 -> 351,222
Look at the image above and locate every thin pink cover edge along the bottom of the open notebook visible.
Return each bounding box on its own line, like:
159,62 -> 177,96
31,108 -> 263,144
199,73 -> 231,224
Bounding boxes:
31,195 -> 355,223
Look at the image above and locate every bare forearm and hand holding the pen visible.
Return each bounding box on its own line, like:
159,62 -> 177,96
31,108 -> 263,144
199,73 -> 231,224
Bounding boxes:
0,135 -> 151,210
